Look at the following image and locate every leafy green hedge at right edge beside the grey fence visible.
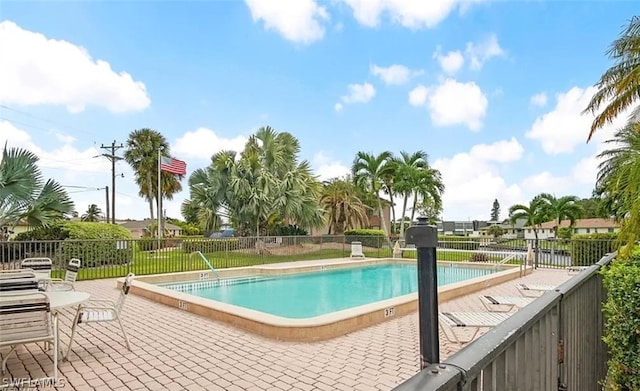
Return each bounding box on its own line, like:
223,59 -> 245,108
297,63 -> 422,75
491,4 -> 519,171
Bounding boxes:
603,255 -> 640,391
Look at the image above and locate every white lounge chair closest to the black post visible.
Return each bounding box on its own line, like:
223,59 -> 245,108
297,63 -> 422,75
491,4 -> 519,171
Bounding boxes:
439,312 -> 511,344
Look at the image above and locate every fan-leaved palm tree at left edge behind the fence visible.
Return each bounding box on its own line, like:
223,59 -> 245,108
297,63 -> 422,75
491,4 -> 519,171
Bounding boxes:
0,145 -> 74,228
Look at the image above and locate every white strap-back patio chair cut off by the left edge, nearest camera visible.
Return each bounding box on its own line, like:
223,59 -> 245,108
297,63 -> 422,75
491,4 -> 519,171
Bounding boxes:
0,291 -> 58,380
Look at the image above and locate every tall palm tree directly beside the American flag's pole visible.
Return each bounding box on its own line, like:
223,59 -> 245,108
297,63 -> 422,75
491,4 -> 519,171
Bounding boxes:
124,128 -> 182,219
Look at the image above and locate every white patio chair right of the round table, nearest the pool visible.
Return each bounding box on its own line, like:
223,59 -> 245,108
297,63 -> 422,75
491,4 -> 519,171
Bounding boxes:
64,273 -> 134,360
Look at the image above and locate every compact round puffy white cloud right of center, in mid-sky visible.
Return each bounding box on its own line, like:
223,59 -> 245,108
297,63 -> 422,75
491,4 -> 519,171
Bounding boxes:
427,79 -> 489,131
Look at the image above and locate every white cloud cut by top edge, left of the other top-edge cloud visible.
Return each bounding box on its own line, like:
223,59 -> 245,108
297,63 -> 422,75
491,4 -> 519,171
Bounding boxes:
245,0 -> 329,44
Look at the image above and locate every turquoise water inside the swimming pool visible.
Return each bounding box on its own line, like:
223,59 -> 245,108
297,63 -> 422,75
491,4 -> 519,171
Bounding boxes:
164,264 -> 495,319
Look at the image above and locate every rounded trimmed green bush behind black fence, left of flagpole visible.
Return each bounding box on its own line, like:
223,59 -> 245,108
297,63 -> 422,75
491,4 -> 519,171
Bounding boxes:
57,222 -> 133,267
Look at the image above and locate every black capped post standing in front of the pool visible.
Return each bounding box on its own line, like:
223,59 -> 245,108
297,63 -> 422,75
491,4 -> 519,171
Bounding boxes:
405,217 -> 440,369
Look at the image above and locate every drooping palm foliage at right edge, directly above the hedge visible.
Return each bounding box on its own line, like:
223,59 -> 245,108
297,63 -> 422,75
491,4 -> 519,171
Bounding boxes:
596,122 -> 640,251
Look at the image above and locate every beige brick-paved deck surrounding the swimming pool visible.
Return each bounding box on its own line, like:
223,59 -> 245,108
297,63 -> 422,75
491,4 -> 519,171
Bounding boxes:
0,261 -> 573,391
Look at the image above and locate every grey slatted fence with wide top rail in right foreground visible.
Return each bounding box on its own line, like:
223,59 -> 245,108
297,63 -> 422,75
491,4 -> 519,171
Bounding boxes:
395,253 -> 616,391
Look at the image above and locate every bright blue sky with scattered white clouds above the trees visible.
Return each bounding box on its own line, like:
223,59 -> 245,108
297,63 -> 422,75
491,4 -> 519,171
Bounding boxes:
0,0 -> 637,224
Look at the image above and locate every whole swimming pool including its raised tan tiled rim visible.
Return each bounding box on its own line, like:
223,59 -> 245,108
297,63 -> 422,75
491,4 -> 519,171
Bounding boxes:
127,258 -> 530,342
